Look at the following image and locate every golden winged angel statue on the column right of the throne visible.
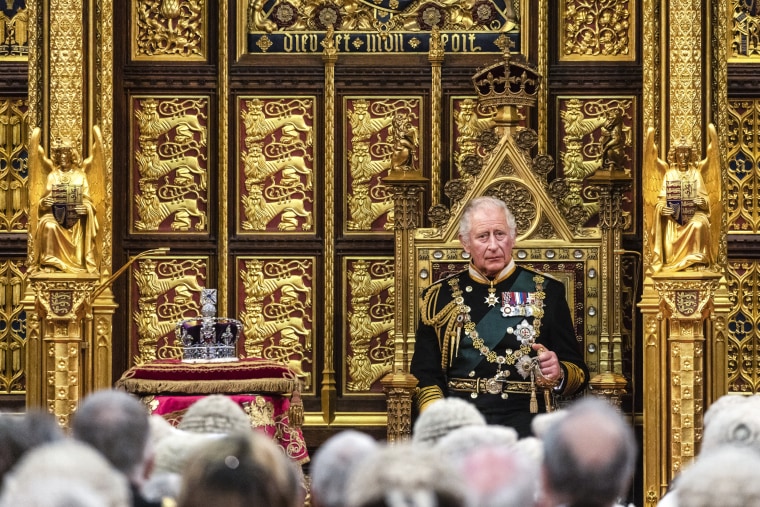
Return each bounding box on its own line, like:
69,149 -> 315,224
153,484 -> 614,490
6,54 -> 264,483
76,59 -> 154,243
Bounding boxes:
644,123 -> 722,274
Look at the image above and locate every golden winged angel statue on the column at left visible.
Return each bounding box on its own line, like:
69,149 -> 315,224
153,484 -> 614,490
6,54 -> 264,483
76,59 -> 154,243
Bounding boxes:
29,126 -> 105,274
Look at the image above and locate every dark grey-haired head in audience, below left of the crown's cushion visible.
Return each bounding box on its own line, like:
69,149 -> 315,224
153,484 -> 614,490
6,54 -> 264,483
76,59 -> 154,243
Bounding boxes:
71,389 -> 153,500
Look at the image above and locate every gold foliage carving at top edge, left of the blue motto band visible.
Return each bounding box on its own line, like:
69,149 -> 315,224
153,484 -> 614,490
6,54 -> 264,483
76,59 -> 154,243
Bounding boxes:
130,0 -> 208,60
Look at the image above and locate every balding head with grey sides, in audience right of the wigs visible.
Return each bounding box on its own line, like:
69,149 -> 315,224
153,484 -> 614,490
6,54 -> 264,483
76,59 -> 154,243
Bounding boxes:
542,397 -> 636,507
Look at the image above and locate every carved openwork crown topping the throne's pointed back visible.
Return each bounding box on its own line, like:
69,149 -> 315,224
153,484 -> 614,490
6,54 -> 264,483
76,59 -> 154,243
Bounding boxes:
472,36 -> 541,107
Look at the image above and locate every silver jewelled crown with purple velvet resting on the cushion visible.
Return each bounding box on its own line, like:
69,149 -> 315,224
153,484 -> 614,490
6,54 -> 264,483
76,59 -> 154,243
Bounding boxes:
174,289 -> 243,362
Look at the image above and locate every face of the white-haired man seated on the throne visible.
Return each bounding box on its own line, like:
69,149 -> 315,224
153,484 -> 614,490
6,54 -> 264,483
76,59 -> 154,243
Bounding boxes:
459,208 -> 514,276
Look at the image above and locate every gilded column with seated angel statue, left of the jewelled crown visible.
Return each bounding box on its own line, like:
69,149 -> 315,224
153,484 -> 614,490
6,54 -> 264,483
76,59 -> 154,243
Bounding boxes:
23,0 -> 116,426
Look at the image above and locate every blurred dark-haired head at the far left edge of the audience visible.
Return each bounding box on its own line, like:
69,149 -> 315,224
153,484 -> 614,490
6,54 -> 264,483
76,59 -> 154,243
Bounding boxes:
0,409 -> 64,483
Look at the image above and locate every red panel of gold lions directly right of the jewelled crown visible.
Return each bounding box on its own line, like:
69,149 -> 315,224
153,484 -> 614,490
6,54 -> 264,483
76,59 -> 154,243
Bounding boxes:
236,256 -> 312,394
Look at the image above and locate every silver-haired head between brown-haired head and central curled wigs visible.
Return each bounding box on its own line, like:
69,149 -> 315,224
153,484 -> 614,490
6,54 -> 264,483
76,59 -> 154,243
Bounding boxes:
310,430 -> 380,507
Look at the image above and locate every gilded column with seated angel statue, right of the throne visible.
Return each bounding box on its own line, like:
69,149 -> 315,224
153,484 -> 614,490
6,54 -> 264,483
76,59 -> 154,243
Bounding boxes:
639,0 -> 729,498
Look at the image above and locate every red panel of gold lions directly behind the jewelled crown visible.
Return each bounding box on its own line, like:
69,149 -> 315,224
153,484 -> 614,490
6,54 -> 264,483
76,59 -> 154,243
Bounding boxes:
129,256 -> 213,364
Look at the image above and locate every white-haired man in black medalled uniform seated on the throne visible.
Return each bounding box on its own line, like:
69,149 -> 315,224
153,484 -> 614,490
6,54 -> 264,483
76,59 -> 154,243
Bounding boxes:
411,197 -> 589,436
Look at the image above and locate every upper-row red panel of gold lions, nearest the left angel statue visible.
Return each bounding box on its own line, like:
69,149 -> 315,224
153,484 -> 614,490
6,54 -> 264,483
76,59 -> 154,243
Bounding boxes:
130,96 -> 209,234
